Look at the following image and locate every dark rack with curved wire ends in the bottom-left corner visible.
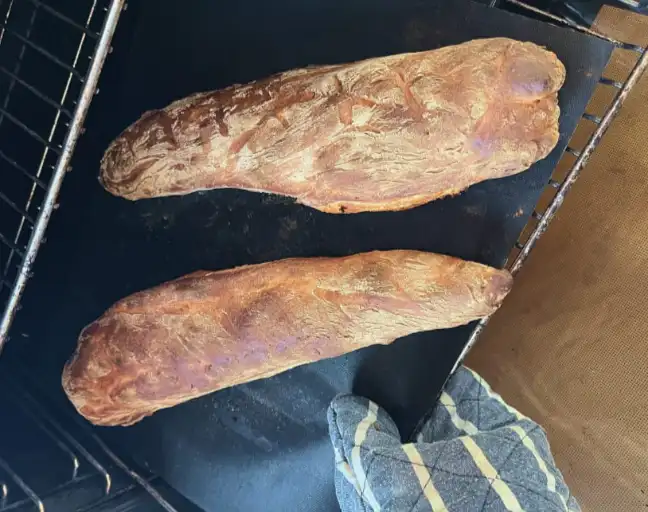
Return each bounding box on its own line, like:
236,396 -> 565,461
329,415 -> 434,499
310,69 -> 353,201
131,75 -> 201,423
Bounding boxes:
0,369 -> 186,512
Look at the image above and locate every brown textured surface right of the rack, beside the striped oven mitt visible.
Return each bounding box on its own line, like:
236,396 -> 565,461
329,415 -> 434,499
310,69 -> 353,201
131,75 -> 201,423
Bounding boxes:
467,8 -> 648,512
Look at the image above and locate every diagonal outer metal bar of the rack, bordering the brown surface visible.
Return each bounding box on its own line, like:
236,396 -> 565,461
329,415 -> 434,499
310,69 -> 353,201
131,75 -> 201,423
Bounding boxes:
452,38 -> 648,373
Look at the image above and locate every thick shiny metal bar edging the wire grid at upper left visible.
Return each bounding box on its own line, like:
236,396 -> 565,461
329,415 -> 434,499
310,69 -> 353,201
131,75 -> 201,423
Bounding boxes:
0,0 -> 125,351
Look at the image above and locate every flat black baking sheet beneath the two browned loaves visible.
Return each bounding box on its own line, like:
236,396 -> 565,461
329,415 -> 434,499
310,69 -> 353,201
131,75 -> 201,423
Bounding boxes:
4,0 -> 611,511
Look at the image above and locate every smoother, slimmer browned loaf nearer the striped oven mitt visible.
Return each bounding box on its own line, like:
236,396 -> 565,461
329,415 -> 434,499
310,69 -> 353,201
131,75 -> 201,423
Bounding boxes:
63,251 -> 511,425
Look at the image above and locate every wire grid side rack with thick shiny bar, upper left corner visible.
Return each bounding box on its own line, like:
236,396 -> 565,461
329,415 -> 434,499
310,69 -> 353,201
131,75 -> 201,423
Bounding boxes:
0,0 -> 124,349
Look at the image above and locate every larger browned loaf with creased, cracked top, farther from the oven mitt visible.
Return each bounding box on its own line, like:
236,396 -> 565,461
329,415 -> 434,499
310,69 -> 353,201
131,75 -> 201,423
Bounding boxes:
101,38 -> 565,213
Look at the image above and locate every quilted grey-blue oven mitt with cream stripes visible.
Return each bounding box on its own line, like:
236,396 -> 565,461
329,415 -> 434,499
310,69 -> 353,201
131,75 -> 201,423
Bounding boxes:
328,367 -> 580,512
